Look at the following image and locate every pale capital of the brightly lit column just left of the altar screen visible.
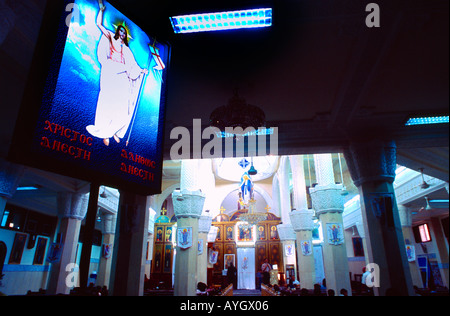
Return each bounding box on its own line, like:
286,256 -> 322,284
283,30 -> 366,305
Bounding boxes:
172,190 -> 205,218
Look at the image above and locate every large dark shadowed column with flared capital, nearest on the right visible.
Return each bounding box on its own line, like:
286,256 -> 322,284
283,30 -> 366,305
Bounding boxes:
345,140 -> 414,295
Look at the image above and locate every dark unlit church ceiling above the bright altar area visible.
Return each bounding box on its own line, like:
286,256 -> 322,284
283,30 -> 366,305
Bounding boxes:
0,0 -> 449,181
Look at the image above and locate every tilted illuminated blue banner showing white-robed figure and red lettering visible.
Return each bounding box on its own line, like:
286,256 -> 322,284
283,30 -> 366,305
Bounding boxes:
8,0 -> 170,194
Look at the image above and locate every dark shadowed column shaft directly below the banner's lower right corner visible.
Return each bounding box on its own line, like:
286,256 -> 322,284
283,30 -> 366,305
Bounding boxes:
110,191 -> 149,296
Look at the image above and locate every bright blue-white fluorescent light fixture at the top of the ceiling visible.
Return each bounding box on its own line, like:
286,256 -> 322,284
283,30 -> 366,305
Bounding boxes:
170,8 -> 272,34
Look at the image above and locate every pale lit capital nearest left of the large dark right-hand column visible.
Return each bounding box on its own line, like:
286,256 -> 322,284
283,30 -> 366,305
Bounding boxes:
309,183 -> 344,216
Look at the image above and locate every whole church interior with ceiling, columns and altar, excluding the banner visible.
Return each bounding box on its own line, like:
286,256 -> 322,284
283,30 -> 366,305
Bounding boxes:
0,0 -> 449,297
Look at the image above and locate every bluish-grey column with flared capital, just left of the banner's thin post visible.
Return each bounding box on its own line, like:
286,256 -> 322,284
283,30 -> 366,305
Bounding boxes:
47,192 -> 89,295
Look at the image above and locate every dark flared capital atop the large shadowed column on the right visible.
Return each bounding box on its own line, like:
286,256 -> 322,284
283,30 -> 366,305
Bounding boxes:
344,140 -> 397,187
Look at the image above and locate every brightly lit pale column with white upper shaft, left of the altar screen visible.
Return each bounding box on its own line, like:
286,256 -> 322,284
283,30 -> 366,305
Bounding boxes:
172,160 -> 205,296
